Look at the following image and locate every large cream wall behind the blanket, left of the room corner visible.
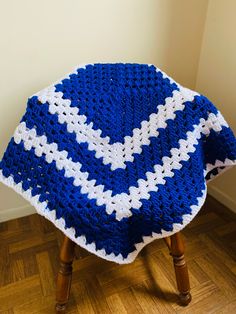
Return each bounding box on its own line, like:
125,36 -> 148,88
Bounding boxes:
0,0 -> 208,220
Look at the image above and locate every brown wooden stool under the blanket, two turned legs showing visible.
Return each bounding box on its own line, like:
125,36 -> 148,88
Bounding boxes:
56,232 -> 191,314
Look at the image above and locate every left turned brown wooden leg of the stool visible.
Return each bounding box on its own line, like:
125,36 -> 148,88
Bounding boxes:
56,237 -> 75,314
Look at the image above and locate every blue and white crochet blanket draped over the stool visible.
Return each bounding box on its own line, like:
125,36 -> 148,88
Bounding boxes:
0,63 -> 236,263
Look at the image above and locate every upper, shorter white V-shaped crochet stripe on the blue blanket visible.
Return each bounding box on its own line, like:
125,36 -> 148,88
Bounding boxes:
36,85 -> 199,170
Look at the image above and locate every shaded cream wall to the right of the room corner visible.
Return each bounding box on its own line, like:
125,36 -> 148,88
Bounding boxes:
196,0 -> 236,212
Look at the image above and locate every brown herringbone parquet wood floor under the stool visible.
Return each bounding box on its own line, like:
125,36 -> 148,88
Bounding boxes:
0,197 -> 236,314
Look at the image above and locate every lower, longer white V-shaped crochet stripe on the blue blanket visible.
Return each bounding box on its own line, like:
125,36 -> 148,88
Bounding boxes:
14,113 -> 230,220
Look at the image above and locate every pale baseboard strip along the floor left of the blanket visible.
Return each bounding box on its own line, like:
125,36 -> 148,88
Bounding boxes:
0,205 -> 36,222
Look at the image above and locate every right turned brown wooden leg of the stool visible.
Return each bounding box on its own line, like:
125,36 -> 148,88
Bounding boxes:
171,232 -> 191,305
